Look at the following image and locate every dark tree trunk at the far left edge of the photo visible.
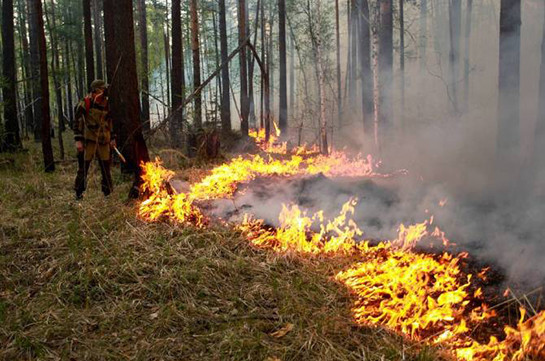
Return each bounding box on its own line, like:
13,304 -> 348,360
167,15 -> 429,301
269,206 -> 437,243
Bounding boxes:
0,0 -> 21,150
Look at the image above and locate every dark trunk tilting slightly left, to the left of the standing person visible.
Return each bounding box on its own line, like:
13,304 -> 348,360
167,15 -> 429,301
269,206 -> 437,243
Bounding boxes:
29,0 -> 55,172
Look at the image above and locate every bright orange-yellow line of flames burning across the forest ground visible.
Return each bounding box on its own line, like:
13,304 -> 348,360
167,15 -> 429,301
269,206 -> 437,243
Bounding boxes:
139,145 -> 545,361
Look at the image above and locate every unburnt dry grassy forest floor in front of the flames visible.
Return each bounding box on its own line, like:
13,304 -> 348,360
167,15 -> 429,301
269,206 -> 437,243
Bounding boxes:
0,139 -> 439,361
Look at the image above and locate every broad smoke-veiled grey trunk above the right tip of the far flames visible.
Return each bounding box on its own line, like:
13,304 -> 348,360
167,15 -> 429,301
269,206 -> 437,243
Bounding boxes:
378,0 -> 393,142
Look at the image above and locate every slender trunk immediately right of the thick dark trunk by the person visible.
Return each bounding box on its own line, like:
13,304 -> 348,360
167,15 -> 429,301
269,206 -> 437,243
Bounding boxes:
138,0 -> 151,130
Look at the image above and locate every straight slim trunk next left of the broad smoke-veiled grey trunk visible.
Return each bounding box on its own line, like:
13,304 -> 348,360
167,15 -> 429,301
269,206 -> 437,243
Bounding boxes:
359,0 -> 373,134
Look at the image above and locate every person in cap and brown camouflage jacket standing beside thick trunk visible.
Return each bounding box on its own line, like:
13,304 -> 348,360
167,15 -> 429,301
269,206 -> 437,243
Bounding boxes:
73,79 -> 116,200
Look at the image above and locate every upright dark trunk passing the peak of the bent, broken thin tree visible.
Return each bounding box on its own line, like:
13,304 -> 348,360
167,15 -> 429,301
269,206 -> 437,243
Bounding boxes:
238,0 -> 250,138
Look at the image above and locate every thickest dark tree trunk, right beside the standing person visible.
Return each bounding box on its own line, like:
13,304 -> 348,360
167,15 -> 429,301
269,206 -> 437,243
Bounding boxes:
104,0 -> 150,198
